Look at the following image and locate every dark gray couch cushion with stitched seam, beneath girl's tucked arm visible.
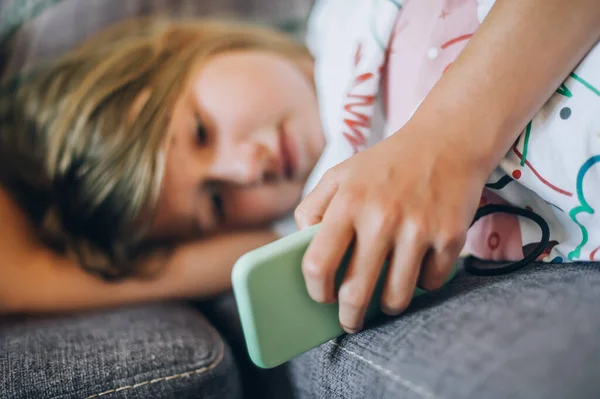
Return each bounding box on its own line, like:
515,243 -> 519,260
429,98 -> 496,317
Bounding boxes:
0,304 -> 242,399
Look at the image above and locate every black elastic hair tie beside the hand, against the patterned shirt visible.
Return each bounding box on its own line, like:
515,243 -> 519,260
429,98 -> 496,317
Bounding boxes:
464,205 -> 550,276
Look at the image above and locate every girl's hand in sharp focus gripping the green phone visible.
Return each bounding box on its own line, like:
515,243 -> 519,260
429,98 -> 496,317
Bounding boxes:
295,122 -> 488,333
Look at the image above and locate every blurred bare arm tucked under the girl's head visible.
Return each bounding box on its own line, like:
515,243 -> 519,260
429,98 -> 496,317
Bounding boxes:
0,231 -> 275,313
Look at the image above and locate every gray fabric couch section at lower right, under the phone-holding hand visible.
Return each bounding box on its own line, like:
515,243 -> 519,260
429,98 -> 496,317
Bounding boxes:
289,264 -> 600,399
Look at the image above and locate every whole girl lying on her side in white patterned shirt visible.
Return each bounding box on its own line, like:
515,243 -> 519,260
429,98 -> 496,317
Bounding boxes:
0,0 -> 600,338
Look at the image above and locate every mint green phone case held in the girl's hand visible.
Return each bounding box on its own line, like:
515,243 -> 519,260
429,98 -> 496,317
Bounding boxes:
232,225 -> 456,368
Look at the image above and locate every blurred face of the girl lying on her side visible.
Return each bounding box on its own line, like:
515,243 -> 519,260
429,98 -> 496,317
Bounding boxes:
150,51 -> 325,239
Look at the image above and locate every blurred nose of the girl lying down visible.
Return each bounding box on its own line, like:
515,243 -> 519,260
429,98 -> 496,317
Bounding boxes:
215,141 -> 276,186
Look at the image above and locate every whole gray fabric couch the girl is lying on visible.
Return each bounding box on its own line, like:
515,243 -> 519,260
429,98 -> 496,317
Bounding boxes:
0,0 -> 600,399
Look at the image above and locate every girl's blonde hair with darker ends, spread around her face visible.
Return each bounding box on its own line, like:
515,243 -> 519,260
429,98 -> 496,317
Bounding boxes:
0,17 -> 310,278
